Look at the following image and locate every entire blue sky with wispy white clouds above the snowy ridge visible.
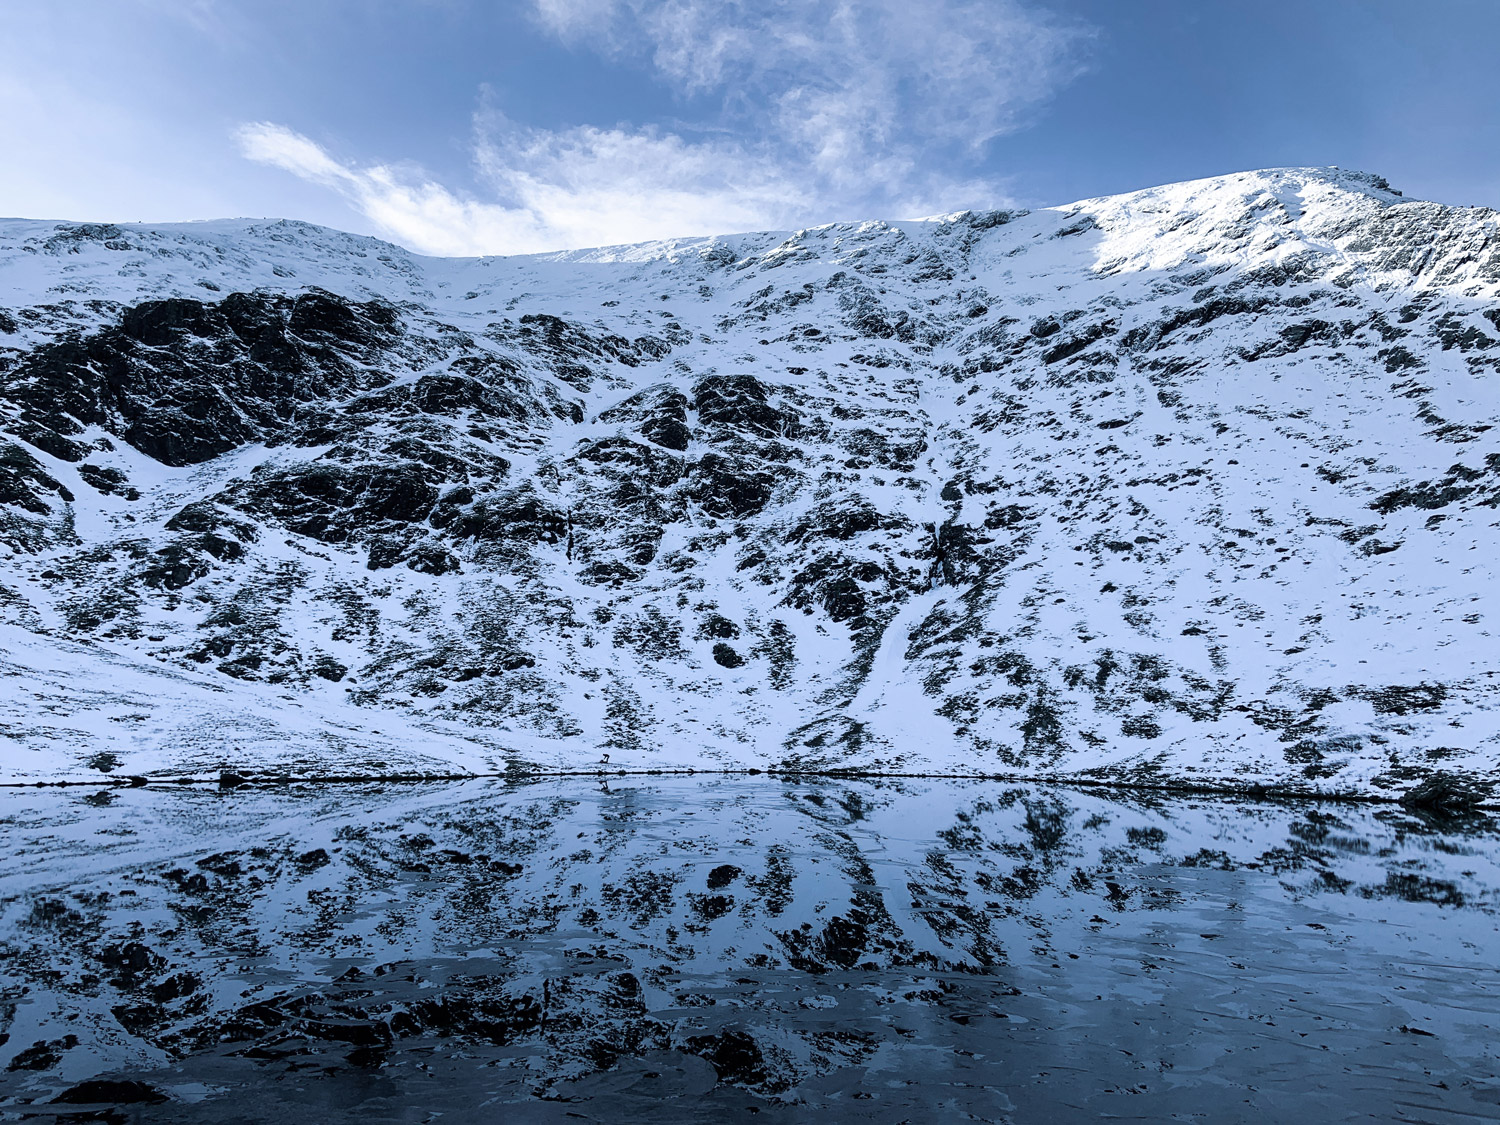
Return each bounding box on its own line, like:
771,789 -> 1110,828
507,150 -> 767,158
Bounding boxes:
0,0 -> 1500,254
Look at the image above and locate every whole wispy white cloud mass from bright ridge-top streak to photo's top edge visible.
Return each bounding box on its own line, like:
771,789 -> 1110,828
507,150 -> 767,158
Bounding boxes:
239,0 -> 1089,254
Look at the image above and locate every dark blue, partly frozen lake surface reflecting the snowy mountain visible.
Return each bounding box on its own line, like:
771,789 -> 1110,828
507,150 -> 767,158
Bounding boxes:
0,777 -> 1500,1124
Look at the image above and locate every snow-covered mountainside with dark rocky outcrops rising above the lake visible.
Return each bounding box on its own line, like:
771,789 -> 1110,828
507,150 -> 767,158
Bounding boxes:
0,170 -> 1500,794
